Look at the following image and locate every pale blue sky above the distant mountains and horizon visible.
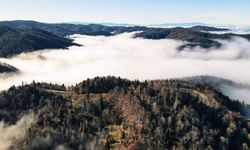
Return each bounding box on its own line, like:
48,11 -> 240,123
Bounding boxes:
0,0 -> 250,25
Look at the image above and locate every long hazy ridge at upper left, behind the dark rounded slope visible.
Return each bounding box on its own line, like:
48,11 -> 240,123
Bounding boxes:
0,20 -> 147,37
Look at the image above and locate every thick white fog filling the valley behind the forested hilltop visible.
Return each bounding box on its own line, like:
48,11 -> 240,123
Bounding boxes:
0,33 -> 250,103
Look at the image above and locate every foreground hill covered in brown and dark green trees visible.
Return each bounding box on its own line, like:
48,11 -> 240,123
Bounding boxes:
0,76 -> 250,150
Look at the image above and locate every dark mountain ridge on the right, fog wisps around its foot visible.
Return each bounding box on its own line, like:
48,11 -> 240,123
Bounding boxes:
135,26 -> 250,50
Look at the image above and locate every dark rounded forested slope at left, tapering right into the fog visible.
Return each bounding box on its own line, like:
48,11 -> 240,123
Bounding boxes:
0,26 -> 76,57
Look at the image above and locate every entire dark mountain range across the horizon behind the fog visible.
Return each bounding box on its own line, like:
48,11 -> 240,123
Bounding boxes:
0,20 -> 250,57
